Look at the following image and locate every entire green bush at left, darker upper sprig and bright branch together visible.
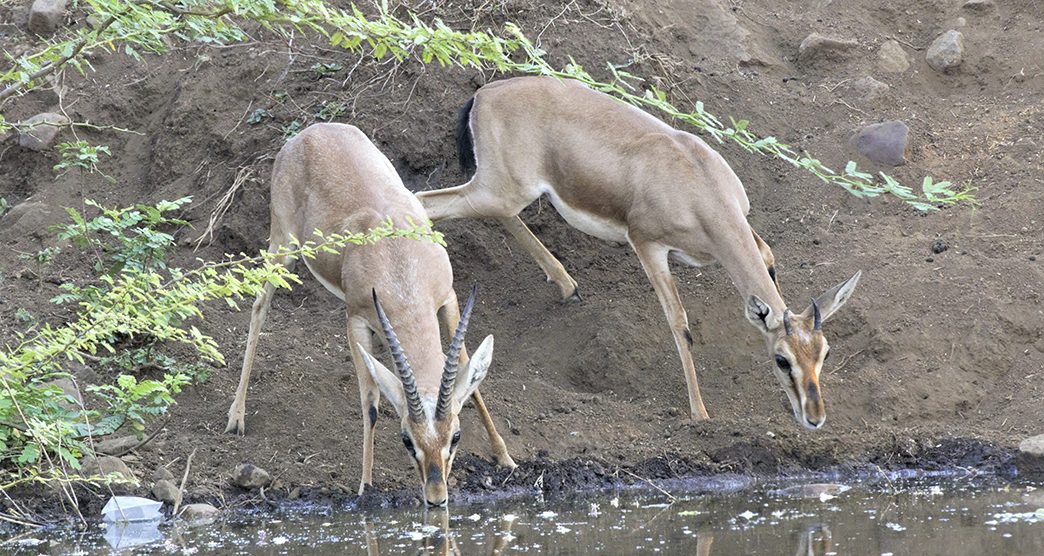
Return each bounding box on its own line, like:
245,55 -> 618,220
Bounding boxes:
0,199 -> 445,484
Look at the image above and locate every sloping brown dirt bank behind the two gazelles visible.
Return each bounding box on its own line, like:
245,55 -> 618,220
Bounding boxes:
0,0 -> 1044,515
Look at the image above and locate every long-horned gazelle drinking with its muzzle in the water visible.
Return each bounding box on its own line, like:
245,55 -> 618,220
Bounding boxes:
226,123 -> 515,506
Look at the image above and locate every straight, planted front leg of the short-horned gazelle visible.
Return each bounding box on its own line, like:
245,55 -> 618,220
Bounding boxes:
631,241 -> 710,420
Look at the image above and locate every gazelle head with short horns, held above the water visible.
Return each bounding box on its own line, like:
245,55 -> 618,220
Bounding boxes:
746,272 -> 861,429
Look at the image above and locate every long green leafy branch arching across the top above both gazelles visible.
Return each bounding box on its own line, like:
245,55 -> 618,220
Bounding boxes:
0,0 -> 974,211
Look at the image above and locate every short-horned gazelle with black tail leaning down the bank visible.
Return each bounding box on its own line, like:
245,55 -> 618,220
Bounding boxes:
418,77 -> 859,428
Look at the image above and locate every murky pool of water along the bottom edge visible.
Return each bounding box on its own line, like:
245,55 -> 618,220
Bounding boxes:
10,480 -> 1044,556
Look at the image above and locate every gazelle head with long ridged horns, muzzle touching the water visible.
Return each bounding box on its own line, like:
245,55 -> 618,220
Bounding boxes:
358,288 -> 493,506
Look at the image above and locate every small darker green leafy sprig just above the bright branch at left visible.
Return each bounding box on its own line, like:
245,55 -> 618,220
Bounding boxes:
51,197 -> 192,273
